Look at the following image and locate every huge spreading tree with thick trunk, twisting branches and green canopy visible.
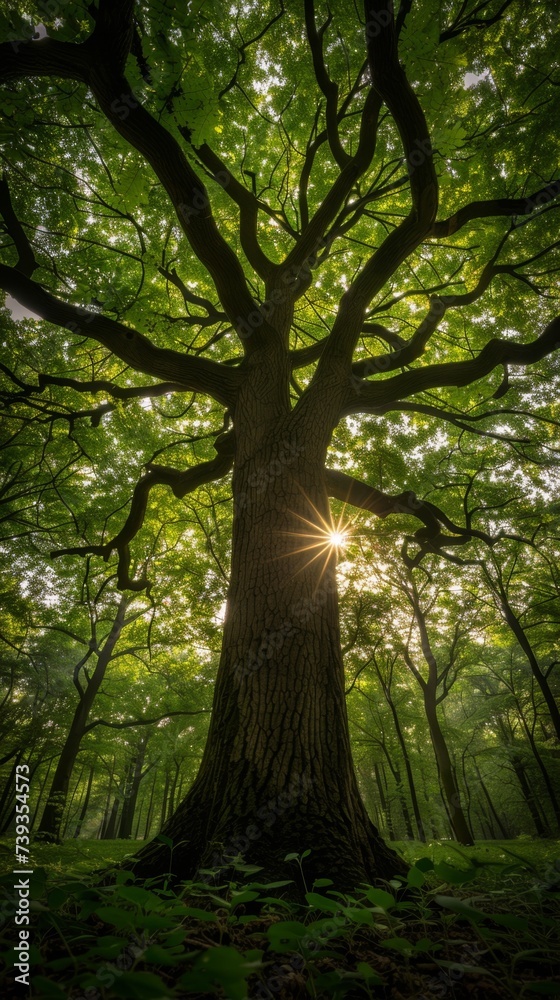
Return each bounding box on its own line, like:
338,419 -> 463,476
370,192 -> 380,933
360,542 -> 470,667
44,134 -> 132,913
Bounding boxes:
0,0 -> 560,886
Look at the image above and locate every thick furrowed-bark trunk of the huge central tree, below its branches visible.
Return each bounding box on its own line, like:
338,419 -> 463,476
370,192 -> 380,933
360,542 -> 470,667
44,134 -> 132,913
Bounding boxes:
131,431 -> 404,888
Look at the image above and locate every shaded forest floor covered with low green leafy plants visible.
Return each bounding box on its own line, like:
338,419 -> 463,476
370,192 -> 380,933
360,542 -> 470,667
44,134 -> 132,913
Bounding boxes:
0,838 -> 560,1000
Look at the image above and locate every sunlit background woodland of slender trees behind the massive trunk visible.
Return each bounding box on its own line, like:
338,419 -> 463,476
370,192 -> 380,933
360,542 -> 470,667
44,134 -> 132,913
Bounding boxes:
0,494 -> 560,852
